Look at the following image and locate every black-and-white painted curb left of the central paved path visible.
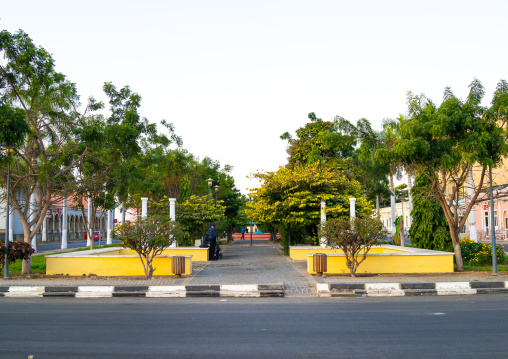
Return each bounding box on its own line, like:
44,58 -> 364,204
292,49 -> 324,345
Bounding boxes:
0,284 -> 284,298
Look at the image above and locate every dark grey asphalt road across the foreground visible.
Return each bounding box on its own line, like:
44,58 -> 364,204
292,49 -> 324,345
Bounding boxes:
0,295 -> 508,359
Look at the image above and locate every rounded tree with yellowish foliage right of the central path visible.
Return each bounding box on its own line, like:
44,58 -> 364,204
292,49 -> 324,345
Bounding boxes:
246,162 -> 372,250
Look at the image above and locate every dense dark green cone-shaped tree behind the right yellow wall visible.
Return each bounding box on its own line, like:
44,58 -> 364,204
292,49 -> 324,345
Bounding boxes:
409,174 -> 453,251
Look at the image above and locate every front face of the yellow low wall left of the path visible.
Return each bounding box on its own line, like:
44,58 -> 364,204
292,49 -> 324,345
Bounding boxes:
46,253 -> 192,276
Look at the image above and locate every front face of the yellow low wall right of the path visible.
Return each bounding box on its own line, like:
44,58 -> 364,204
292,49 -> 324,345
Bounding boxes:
306,253 -> 453,274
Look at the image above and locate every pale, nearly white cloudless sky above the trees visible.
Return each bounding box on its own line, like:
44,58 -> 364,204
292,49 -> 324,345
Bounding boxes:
0,0 -> 508,194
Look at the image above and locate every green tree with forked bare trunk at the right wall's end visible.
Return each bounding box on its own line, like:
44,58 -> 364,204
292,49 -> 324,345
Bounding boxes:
393,79 -> 508,271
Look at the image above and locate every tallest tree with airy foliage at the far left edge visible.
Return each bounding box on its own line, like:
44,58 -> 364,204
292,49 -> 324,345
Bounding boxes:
0,30 -> 97,273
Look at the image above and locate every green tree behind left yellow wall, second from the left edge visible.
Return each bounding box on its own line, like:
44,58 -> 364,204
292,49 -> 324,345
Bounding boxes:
72,83 -> 174,249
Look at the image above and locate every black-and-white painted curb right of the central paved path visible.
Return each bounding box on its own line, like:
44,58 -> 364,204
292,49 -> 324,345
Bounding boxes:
316,281 -> 508,297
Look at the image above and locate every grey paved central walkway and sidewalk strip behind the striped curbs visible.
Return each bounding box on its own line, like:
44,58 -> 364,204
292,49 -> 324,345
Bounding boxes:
0,239 -> 508,297
